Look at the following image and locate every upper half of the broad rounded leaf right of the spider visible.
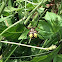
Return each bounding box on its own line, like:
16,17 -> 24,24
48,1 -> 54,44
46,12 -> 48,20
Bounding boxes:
38,20 -> 52,32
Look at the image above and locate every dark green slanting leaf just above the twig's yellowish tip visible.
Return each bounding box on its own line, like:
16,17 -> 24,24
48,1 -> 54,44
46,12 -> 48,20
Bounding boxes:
43,32 -> 60,47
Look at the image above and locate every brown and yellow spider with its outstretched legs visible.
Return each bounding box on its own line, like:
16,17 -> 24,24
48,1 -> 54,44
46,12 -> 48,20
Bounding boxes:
23,21 -> 45,44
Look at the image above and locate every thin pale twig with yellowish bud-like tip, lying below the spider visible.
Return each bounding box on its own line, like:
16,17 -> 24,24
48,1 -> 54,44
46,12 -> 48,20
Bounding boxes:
0,41 -> 56,50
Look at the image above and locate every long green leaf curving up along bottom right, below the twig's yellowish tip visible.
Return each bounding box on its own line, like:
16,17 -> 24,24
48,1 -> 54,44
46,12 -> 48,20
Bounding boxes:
31,43 -> 61,62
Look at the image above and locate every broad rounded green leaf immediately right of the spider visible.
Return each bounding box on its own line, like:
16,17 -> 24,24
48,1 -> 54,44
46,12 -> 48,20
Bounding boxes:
36,20 -> 53,39
